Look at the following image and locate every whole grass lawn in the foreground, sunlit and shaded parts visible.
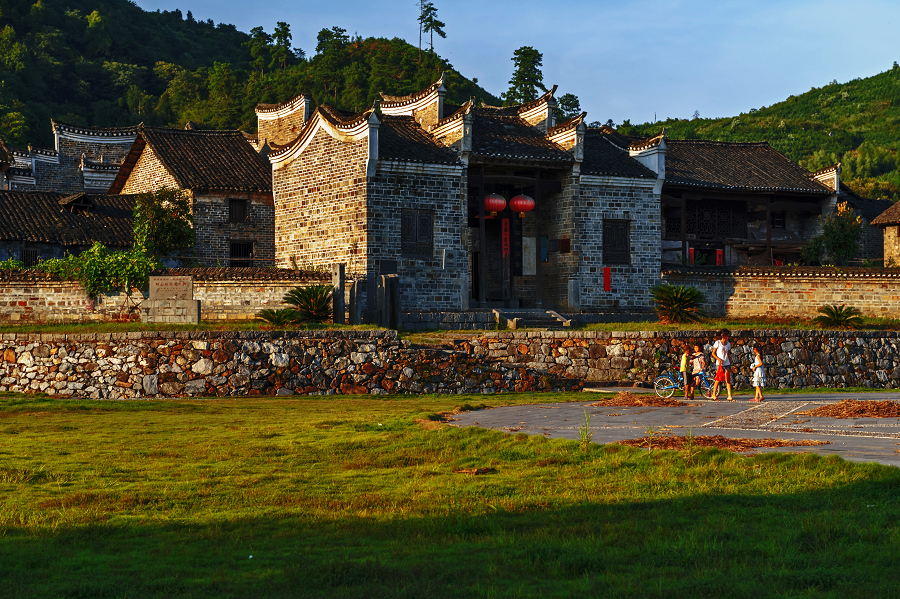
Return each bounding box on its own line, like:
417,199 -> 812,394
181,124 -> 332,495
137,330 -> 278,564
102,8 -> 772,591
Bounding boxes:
0,394 -> 900,599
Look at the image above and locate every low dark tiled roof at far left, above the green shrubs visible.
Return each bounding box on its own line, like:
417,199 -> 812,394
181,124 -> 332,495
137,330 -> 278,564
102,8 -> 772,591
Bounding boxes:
0,191 -> 135,247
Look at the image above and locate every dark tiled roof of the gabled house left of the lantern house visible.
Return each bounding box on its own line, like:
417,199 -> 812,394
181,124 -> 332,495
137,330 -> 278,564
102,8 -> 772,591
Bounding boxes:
109,127 -> 272,193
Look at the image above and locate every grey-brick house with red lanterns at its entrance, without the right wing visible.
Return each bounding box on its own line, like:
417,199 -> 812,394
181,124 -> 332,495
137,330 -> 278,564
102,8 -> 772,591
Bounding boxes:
257,78 -> 662,311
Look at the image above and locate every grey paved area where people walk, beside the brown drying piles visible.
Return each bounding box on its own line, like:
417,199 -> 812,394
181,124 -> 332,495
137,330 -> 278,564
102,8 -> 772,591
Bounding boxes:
453,389 -> 900,466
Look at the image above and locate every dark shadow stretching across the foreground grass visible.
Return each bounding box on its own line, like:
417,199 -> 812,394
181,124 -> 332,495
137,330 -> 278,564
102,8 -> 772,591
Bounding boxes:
0,474 -> 900,599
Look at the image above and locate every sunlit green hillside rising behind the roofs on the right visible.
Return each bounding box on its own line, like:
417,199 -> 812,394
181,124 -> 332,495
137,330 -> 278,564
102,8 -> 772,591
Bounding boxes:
619,63 -> 900,200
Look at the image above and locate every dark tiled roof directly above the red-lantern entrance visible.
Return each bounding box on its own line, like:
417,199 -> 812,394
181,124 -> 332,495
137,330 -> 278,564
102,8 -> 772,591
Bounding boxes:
472,106 -> 575,166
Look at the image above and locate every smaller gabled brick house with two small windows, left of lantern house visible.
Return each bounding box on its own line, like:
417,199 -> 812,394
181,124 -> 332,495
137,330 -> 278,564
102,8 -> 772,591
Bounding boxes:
109,127 -> 275,266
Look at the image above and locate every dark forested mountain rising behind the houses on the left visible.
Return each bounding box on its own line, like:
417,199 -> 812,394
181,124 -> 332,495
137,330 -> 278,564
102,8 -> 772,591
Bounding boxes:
0,0 -> 499,146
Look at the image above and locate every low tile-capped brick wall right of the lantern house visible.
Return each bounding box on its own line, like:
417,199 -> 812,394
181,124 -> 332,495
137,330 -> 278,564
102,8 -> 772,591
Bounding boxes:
662,266 -> 900,318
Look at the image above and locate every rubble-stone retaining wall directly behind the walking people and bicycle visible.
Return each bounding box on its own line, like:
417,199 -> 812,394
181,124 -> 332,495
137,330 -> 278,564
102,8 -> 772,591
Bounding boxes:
457,330 -> 900,389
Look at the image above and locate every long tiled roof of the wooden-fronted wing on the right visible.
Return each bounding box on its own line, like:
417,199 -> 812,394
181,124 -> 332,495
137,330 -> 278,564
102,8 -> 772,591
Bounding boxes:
666,139 -> 831,195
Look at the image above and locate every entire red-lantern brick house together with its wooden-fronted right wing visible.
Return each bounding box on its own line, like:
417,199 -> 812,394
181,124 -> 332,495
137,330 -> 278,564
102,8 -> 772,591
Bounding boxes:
255,74 -> 883,313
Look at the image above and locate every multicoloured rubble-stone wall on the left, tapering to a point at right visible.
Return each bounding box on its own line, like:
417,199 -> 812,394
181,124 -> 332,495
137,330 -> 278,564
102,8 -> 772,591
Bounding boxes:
0,330 -> 583,399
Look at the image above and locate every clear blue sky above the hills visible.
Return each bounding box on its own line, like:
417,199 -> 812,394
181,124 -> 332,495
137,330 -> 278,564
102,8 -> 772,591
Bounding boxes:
137,0 -> 900,123
